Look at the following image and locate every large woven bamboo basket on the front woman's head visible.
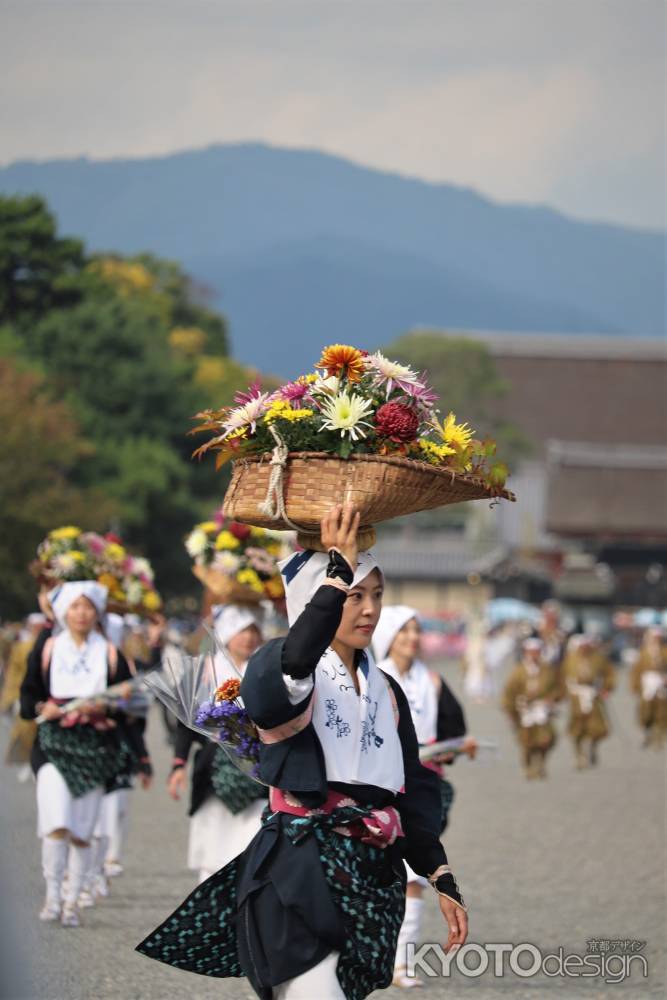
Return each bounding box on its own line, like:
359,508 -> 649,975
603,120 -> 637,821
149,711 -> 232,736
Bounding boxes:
224,452 -> 515,549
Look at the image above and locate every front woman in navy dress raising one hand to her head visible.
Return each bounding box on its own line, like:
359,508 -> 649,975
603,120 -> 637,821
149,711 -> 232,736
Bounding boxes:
138,506 -> 467,1000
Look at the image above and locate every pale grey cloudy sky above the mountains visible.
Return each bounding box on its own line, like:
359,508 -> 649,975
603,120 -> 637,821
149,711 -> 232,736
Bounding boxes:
0,0 -> 666,227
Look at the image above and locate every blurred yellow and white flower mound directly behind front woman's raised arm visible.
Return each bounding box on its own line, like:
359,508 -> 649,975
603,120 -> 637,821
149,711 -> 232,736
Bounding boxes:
185,511 -> 287,603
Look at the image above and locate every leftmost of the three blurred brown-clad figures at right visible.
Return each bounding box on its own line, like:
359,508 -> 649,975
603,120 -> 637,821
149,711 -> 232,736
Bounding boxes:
502,638 -> 560,779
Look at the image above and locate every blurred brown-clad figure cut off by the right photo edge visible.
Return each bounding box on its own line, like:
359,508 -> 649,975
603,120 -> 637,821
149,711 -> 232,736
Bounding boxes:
630,626 -> 667,750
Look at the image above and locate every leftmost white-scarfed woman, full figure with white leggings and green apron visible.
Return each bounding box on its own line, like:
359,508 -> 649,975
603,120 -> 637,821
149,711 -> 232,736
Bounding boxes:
21,580 -> 131,927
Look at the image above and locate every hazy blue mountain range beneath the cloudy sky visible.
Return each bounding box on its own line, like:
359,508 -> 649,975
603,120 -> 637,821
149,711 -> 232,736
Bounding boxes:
0,140 -> 665,376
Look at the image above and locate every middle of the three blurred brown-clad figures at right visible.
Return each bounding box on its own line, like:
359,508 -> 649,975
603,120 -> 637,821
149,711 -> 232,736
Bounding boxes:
563,633 -> 616,770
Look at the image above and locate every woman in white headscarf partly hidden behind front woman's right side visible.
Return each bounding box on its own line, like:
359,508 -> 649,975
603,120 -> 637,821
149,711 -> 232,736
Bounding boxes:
373,604 -> 476,989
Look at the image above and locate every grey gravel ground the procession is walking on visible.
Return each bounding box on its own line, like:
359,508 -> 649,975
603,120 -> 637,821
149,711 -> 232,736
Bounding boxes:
0,672 -> 667,1000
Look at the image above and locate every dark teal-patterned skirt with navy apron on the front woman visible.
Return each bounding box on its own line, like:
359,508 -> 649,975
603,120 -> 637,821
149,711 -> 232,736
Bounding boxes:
137,807 -> 405,1000
